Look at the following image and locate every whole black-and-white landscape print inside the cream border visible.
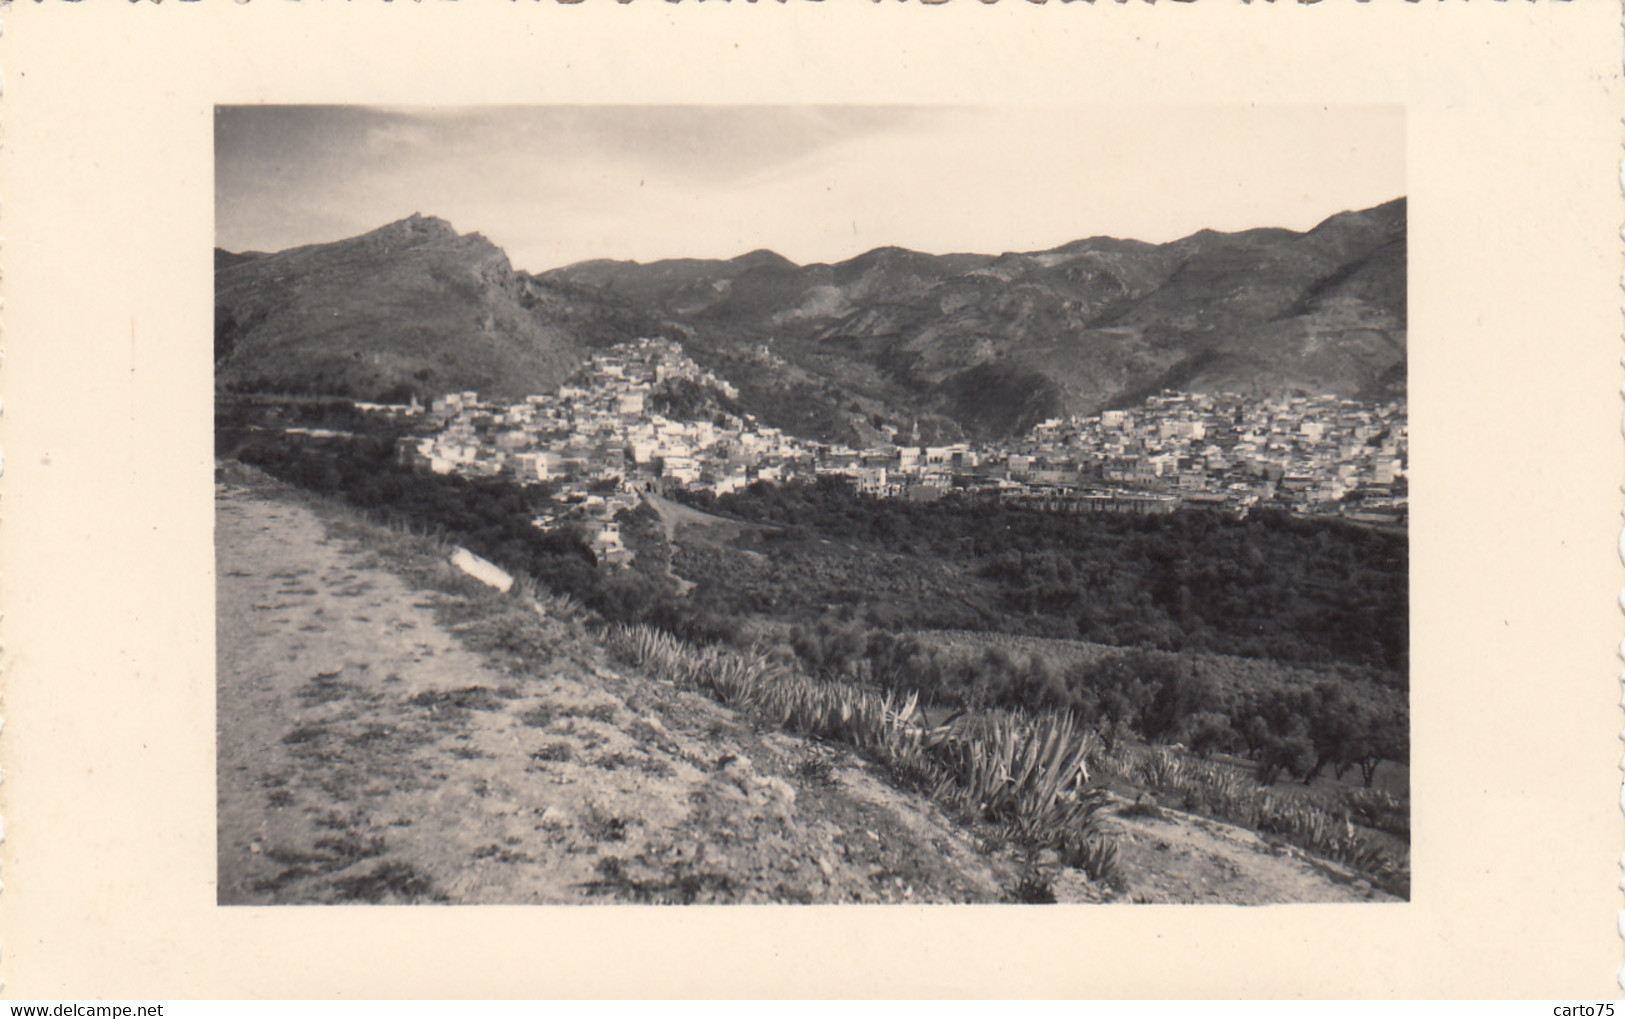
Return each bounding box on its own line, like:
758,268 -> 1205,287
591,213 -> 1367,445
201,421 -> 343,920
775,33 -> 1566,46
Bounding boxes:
213,106 -> 1411,905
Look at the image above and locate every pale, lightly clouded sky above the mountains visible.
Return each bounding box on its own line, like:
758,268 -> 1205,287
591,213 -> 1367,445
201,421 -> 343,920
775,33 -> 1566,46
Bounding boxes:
215,106 -> 1406,271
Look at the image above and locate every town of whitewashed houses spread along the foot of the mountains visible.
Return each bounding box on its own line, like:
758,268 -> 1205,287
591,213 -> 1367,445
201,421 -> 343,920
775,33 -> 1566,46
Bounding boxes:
386,338 -> 1407,562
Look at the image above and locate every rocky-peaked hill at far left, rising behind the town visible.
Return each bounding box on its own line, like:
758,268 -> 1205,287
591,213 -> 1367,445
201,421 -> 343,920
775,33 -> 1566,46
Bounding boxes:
215,215 -> 653,401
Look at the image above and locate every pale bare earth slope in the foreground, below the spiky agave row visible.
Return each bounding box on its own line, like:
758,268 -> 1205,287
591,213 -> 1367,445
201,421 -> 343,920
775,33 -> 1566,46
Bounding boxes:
216,463 -> 1381,904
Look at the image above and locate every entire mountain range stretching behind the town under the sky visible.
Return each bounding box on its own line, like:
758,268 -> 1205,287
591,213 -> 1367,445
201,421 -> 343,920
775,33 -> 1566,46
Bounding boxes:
215,198 -> 1406,442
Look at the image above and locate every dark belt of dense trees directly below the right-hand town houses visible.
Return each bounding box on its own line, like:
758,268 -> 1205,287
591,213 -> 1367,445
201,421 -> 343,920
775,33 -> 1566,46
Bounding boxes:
678,478 -> 1409,673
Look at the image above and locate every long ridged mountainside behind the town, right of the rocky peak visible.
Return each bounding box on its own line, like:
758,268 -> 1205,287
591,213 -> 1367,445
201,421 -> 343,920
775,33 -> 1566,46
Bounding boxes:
544,198 -> 1406,437
